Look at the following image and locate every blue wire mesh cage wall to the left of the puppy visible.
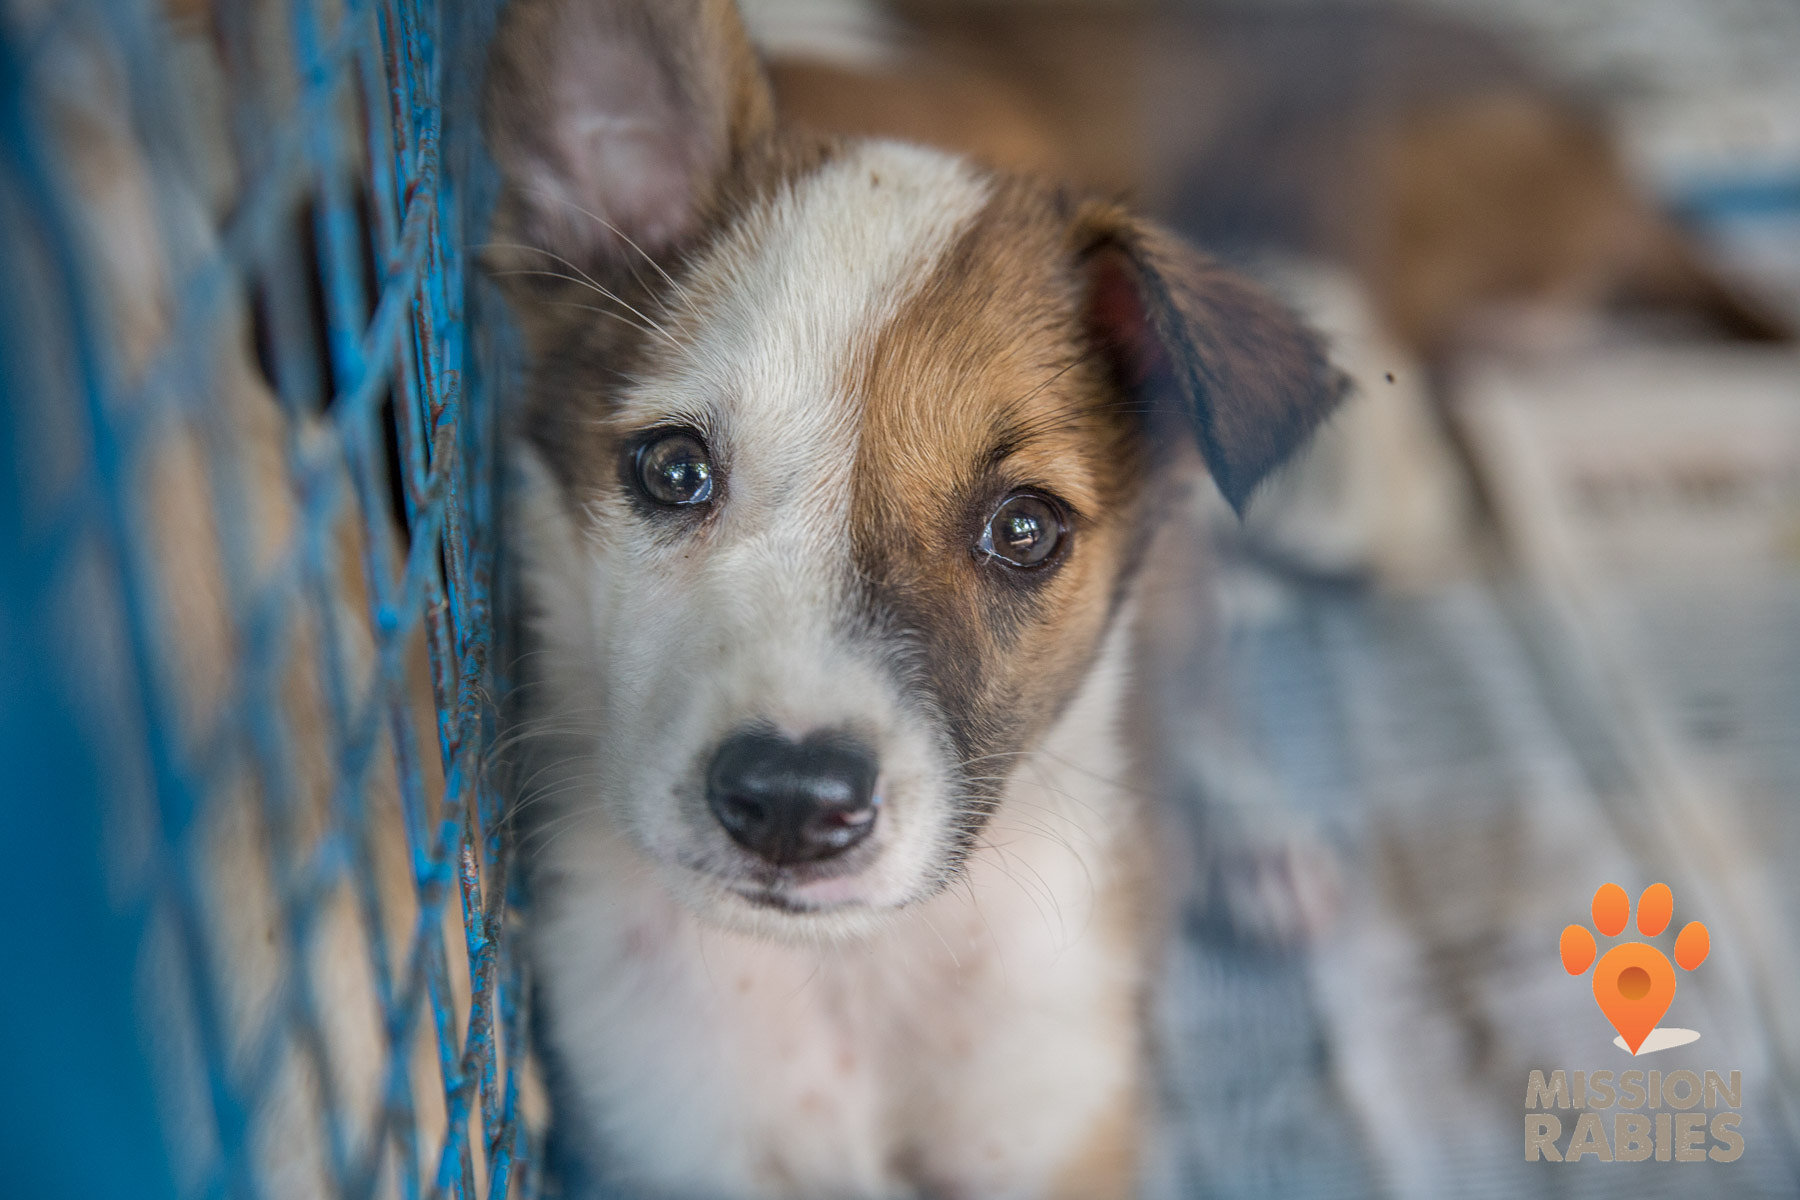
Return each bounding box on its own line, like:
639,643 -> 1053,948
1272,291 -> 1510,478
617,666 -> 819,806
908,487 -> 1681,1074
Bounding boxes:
0,0 -> 536,1198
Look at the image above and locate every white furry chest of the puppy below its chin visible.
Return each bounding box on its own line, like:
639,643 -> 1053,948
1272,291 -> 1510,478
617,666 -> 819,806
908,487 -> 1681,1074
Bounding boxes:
545,813 -> 1138,1196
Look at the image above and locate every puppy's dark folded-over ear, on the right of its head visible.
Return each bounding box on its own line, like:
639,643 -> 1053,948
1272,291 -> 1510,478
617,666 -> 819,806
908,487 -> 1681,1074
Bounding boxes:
1075,205 -> 1346,513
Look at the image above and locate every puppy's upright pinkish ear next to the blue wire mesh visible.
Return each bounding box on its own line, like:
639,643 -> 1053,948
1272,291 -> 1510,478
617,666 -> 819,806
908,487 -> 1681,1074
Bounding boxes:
482,0 -> 774,273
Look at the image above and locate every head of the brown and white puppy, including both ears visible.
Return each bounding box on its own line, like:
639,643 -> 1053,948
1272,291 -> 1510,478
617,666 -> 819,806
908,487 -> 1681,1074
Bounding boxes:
488,0 -> 1332,934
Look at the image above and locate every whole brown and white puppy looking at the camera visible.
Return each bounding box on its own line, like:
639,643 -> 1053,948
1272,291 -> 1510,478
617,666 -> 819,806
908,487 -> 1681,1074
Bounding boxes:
486,0 -> 1339,1200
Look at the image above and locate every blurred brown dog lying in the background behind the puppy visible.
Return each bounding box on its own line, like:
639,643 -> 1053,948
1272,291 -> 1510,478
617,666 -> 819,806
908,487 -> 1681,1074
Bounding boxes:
749,0 -> 1789,360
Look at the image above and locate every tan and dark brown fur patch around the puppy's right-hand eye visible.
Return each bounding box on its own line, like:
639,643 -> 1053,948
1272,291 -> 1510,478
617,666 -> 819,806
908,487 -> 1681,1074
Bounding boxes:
851,182 -> 1147,816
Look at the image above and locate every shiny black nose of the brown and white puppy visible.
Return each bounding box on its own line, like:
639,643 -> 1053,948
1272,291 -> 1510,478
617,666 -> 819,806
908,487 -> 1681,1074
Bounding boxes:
706,732 -> 875,865
